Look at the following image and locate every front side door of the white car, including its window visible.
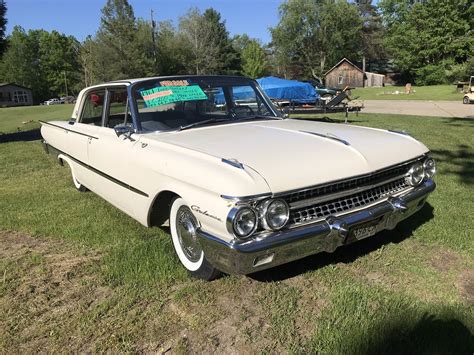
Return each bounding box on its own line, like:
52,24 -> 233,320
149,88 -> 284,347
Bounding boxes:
83,86 -> 148,216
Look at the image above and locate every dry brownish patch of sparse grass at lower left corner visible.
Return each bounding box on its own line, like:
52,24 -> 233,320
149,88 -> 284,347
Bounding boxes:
0,231 -> 105,352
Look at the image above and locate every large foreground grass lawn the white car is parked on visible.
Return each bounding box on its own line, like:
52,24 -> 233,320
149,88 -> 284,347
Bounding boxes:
0,110 -> 474,354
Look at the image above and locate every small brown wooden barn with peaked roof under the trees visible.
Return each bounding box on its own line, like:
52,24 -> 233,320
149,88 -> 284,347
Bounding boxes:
324,58 -> 364,89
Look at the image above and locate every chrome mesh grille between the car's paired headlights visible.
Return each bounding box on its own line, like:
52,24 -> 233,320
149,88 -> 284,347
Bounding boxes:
290,177 -> 408,225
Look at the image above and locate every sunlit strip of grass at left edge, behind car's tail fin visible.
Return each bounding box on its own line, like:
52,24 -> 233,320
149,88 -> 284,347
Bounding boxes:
0,104 -> 74,134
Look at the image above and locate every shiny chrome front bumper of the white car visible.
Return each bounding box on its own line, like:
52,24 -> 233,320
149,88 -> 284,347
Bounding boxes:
198,179 -> 436,274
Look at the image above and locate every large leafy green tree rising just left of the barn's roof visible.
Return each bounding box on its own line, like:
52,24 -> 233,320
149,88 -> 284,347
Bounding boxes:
271,0 -> 362,78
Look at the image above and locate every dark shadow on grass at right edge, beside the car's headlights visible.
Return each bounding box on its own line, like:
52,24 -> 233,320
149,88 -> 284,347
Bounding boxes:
431,144 -> 474,185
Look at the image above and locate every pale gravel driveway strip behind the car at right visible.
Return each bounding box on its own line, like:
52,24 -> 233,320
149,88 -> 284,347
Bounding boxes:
362,100 -> 474,118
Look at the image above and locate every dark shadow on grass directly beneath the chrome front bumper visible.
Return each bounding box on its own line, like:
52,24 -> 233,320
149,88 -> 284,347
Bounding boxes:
248,203 -> 434,282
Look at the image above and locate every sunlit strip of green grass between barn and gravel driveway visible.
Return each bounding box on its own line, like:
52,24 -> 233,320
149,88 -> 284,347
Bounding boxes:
352,85 -> 463,102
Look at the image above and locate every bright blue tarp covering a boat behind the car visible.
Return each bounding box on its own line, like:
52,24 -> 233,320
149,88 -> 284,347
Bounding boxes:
257,76 -> 319,104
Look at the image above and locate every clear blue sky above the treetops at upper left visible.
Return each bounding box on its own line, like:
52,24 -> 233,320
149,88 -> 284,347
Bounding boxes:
6,0 -> 281,42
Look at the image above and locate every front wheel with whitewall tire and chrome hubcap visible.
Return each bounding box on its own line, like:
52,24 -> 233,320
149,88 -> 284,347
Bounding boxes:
170,197 -> 220,281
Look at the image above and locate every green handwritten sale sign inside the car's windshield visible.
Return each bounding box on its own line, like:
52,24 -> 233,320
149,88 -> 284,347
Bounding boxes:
140,85 -> 207,107
